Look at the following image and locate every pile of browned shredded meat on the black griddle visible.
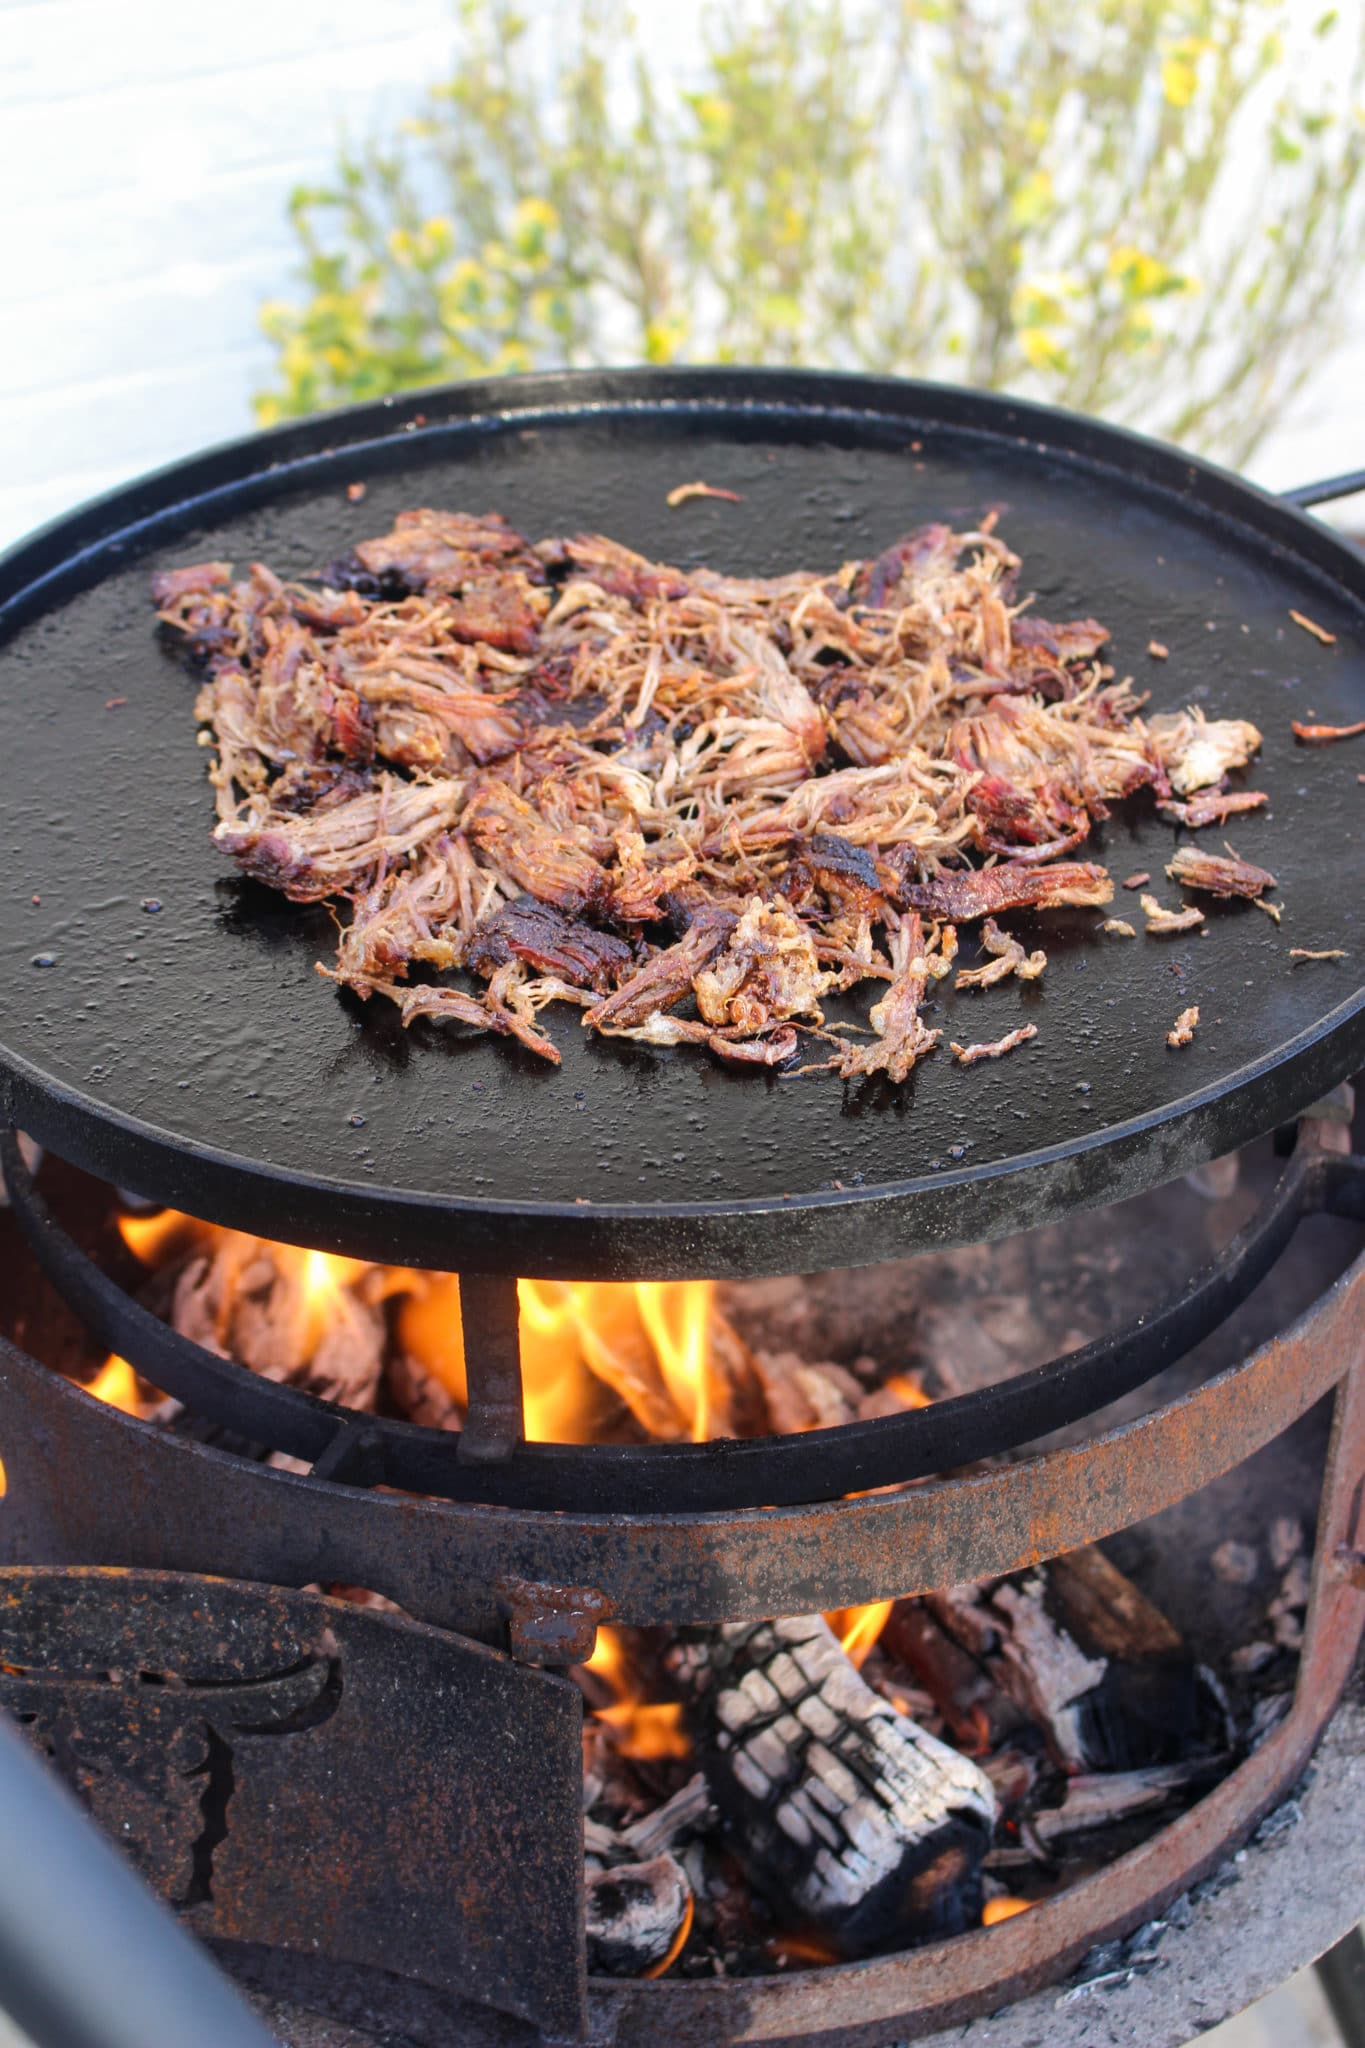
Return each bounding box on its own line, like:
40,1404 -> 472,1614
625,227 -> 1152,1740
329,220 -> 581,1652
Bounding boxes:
151,510 -> 1261,1081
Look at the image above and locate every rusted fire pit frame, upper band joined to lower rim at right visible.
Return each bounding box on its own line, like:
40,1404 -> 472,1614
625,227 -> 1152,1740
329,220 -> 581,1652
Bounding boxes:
0,1228 -> 1365,2048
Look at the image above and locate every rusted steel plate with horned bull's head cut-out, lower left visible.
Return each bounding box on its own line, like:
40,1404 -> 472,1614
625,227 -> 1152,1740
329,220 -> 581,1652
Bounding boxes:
0,1569 -> 587,2040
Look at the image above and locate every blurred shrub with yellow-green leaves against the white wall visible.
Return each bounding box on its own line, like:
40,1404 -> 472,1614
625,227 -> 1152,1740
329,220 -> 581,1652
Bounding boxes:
258,0 -> 1365,461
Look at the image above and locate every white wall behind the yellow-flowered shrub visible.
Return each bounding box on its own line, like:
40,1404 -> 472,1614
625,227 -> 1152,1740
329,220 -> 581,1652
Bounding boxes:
0,0 -> 1365,545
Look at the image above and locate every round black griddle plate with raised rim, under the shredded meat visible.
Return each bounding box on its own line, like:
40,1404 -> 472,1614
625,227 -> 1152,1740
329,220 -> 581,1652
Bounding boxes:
0,371 -> 1365,1278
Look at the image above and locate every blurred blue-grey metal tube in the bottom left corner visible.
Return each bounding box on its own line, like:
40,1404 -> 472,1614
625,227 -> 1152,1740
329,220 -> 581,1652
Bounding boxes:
0,1714 -> 272,2048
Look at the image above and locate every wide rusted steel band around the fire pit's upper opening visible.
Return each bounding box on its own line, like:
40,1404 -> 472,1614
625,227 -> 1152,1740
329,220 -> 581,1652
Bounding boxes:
0,1157 -> 1365,1630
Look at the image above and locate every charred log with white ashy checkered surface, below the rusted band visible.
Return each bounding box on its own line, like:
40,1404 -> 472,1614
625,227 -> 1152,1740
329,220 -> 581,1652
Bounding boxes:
675,1614 -> 997,1956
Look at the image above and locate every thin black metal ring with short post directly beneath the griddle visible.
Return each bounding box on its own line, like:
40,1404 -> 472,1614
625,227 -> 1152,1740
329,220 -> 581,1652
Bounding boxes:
0,1133 -> 1365,1531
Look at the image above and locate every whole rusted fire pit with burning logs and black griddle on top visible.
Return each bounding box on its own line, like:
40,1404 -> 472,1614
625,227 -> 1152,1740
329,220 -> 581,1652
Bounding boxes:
0,375 -> 1365,2044
